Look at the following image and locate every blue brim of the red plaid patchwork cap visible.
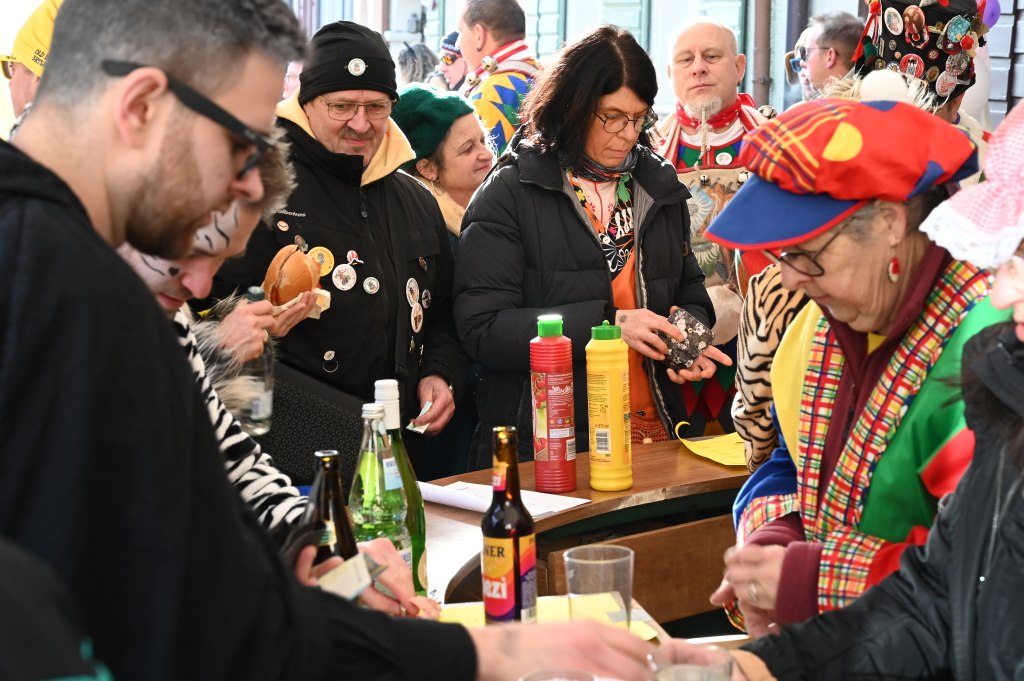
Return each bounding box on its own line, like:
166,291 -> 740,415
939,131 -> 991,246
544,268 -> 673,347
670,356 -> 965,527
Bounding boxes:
705,174 -> 867,251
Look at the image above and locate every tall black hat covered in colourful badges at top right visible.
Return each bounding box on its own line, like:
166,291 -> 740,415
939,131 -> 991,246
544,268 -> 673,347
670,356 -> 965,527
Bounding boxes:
854,0 -> 988,101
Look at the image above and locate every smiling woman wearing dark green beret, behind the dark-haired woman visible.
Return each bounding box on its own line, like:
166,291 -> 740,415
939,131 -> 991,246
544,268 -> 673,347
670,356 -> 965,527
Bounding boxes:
391,83 -> 495,480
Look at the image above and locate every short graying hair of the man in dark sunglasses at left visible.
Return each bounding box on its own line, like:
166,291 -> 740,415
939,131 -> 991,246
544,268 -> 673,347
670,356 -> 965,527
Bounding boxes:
36,0 -> 306,107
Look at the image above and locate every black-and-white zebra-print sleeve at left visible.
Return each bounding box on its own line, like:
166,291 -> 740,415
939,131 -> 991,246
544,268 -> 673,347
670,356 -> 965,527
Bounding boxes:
174,311 -> 306,529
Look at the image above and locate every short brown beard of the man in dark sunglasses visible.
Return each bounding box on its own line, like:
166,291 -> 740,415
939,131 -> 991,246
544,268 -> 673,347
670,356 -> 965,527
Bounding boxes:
125,116 -> 208,260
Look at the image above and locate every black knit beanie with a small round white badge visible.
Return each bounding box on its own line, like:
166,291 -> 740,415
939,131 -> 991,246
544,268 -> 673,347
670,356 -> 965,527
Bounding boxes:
299,22 -> 398,104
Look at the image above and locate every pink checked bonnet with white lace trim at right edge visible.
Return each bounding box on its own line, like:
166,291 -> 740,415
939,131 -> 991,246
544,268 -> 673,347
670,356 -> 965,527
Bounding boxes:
921,98 -> 1024,269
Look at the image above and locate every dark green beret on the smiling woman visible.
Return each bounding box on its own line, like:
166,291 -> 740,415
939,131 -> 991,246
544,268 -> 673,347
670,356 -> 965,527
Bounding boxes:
391,83 -> 474,173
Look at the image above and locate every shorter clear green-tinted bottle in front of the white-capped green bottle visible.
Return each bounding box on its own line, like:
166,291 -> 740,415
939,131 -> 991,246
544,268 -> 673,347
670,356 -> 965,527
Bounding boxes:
348,403 -> 413,569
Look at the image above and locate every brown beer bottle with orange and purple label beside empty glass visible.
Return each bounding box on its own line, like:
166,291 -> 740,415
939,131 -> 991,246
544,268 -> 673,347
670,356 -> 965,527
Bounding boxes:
480,426 -> 537,625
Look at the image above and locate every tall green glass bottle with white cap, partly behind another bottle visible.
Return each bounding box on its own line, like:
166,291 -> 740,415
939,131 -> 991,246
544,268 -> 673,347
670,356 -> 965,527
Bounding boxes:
374,379 -> 427,596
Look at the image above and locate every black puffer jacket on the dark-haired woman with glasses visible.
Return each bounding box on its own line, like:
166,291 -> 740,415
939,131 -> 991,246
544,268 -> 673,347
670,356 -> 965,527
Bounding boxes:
453,138 -> 715,468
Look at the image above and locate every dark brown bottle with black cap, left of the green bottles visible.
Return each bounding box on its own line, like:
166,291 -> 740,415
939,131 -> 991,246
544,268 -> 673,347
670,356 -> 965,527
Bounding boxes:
302,450 -> 359,563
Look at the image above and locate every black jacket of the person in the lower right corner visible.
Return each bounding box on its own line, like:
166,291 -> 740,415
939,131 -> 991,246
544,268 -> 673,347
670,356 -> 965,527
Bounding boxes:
745,328 -> 1024,681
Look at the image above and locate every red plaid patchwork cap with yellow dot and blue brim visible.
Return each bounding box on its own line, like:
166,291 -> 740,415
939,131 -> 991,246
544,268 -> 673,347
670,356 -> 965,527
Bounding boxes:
706,99 -> 978,250
